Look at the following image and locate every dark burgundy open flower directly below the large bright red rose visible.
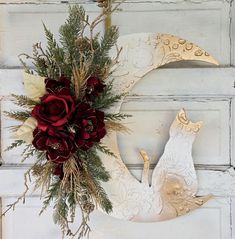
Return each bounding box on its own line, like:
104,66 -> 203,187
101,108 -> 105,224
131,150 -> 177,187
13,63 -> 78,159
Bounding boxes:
32,128 -> 76,163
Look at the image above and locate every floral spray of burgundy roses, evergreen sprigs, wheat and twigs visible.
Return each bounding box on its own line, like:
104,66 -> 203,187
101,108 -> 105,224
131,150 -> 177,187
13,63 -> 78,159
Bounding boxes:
3,0 -> 128,238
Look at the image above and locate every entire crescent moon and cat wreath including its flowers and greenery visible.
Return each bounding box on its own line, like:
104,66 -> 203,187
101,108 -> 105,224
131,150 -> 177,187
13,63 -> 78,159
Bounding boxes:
2,4 -> 218,238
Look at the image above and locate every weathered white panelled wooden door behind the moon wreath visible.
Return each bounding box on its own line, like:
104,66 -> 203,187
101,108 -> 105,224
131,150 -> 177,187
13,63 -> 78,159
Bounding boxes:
0,0 -> 235,239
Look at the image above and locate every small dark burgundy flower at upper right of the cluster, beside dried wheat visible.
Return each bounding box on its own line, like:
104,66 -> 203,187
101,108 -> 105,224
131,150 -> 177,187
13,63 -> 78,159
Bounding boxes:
85,76 -> 105,101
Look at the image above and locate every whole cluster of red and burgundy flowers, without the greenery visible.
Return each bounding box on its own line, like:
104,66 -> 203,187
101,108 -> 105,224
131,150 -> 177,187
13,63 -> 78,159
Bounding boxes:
32,76 -> 106,166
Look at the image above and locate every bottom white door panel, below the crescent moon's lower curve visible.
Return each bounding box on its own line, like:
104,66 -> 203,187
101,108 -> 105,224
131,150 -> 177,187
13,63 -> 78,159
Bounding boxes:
2,198 -> 231,239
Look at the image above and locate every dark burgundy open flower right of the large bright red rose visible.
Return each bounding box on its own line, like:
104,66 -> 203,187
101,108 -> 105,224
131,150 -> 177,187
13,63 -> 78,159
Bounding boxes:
73,103 -> 106,150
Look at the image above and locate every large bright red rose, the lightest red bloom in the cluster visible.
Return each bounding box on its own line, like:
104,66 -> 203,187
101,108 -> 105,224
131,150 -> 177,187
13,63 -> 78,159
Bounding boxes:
32,94 -> 74,131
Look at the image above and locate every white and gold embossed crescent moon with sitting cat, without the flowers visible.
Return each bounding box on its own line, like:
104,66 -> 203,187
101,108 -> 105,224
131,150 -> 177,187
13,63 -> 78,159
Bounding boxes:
99,33 -> 218,222
